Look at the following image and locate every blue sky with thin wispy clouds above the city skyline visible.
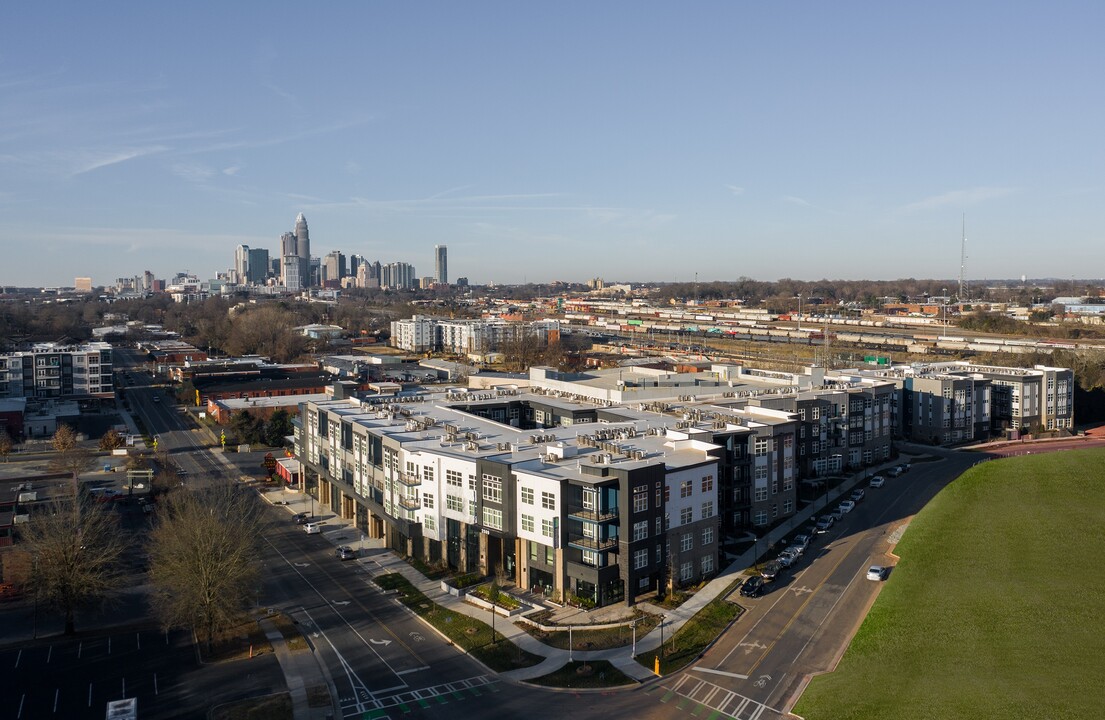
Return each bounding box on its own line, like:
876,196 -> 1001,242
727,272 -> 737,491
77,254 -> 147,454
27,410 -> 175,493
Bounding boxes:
0,0 -> 1105,285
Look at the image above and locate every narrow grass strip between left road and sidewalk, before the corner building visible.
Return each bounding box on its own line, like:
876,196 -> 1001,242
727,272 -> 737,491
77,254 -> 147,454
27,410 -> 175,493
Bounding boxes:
375,573 -> 544,673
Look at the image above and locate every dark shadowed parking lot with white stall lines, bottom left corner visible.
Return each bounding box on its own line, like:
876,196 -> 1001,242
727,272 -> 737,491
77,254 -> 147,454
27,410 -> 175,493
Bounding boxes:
0,629 -> 197,720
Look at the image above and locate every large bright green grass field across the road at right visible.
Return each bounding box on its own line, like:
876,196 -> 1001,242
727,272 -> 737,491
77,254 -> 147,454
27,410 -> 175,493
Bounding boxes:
794,451 -> 1105,720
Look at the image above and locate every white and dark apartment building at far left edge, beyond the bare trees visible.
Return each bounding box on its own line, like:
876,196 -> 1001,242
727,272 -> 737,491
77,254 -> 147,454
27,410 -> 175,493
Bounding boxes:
0,342 -> 115,400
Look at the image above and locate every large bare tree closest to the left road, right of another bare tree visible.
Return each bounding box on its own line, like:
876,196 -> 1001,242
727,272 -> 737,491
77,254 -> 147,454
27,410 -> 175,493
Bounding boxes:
149,487 -> 261,650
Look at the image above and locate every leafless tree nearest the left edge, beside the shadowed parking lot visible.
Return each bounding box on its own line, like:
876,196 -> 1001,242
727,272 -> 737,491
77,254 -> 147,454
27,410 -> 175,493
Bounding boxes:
23,496 -> 124,635
